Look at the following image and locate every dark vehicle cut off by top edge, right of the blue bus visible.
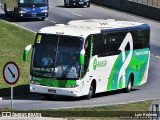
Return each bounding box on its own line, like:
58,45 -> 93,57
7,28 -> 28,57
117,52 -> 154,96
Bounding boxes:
64,0 -> 90,7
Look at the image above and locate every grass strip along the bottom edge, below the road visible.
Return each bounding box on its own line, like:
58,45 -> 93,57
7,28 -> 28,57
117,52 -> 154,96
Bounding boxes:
0,100 -> 152,120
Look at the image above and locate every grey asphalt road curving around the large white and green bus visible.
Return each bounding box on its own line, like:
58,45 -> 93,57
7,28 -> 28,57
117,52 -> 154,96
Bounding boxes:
0,0 -> 160,110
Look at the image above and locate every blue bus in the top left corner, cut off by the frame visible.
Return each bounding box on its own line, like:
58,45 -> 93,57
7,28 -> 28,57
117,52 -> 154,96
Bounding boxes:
1,0 -> 49,20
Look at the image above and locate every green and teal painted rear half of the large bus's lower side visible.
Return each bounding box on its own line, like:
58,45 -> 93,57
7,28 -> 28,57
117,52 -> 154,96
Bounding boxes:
107,48 -> 150,90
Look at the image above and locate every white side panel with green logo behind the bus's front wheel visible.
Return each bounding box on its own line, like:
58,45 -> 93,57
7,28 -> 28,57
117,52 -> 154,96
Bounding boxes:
84,55 -> 118,93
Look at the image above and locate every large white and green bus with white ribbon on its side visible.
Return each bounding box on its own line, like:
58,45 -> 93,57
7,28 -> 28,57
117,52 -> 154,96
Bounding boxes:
23,19 -> 150,99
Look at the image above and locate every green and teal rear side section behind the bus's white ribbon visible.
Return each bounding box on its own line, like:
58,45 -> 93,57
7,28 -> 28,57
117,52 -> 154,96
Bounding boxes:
126,48 -> 150,86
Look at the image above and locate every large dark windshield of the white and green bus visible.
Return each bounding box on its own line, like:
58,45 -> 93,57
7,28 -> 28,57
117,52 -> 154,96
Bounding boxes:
31,34 -> 83,79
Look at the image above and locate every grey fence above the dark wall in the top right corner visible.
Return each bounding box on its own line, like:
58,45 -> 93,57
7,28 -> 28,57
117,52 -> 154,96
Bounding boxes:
128,0 -> 160,8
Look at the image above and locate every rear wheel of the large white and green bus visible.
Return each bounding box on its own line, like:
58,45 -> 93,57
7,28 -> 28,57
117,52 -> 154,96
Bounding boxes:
125,73 -> 134,93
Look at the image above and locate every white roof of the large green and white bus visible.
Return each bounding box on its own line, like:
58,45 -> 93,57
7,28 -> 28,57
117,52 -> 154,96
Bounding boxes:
39,19 -> 149,38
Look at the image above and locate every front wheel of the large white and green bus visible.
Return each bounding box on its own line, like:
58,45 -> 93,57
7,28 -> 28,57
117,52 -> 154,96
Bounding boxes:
86,79 -> 96,99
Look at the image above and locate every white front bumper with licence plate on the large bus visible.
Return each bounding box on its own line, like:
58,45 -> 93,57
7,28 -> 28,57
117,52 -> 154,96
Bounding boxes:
30,83 -> 82,97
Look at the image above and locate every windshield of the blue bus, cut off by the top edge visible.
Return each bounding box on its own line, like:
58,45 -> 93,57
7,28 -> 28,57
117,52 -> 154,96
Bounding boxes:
19,0 -> 48,6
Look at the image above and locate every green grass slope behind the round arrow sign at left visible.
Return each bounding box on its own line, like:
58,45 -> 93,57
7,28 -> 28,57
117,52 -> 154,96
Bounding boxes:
0,20 -> 35,89
